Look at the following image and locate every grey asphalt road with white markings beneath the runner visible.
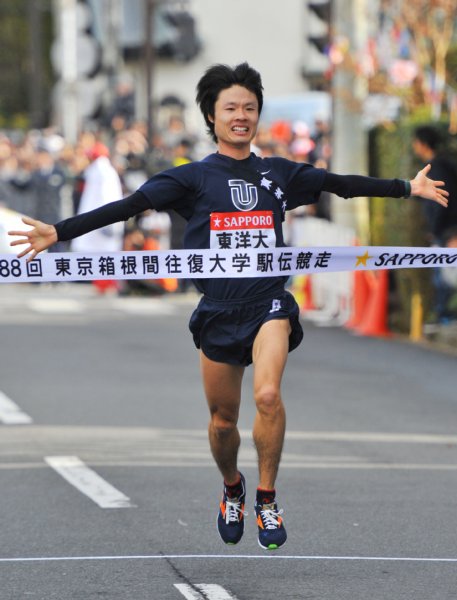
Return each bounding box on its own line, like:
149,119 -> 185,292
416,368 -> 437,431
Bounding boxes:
0,284 -> 457,600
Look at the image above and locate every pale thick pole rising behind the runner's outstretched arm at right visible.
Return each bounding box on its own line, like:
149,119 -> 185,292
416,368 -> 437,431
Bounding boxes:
332,0 -> 369,243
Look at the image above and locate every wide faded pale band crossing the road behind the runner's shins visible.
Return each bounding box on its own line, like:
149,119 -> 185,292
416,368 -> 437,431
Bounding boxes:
0,424 -> 457,473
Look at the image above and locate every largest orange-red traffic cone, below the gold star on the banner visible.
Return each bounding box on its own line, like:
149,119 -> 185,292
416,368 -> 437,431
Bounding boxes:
355,270 -> 391,337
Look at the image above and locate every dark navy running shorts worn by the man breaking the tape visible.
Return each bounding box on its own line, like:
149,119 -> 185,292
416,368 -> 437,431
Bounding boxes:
189,290 -> 303,366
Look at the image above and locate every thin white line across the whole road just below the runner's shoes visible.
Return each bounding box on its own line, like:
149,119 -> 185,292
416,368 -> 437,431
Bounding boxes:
0,554 -> 457,563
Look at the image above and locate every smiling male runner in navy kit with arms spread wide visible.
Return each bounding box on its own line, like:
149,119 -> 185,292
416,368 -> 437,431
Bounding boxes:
11,63 -> 447,549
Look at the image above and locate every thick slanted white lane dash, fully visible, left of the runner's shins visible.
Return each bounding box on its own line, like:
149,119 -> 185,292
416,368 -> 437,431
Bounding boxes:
44,456 -> 135,508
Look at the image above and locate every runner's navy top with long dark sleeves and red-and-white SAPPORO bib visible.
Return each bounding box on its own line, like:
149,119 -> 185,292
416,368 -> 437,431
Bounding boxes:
55,153 -> 406,300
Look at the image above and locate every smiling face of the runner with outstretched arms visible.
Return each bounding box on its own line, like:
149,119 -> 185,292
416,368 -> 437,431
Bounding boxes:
210,85 -> 259,155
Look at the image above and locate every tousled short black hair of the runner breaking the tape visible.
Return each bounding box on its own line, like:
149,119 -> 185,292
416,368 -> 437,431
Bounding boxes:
196,62 -> 263,142
